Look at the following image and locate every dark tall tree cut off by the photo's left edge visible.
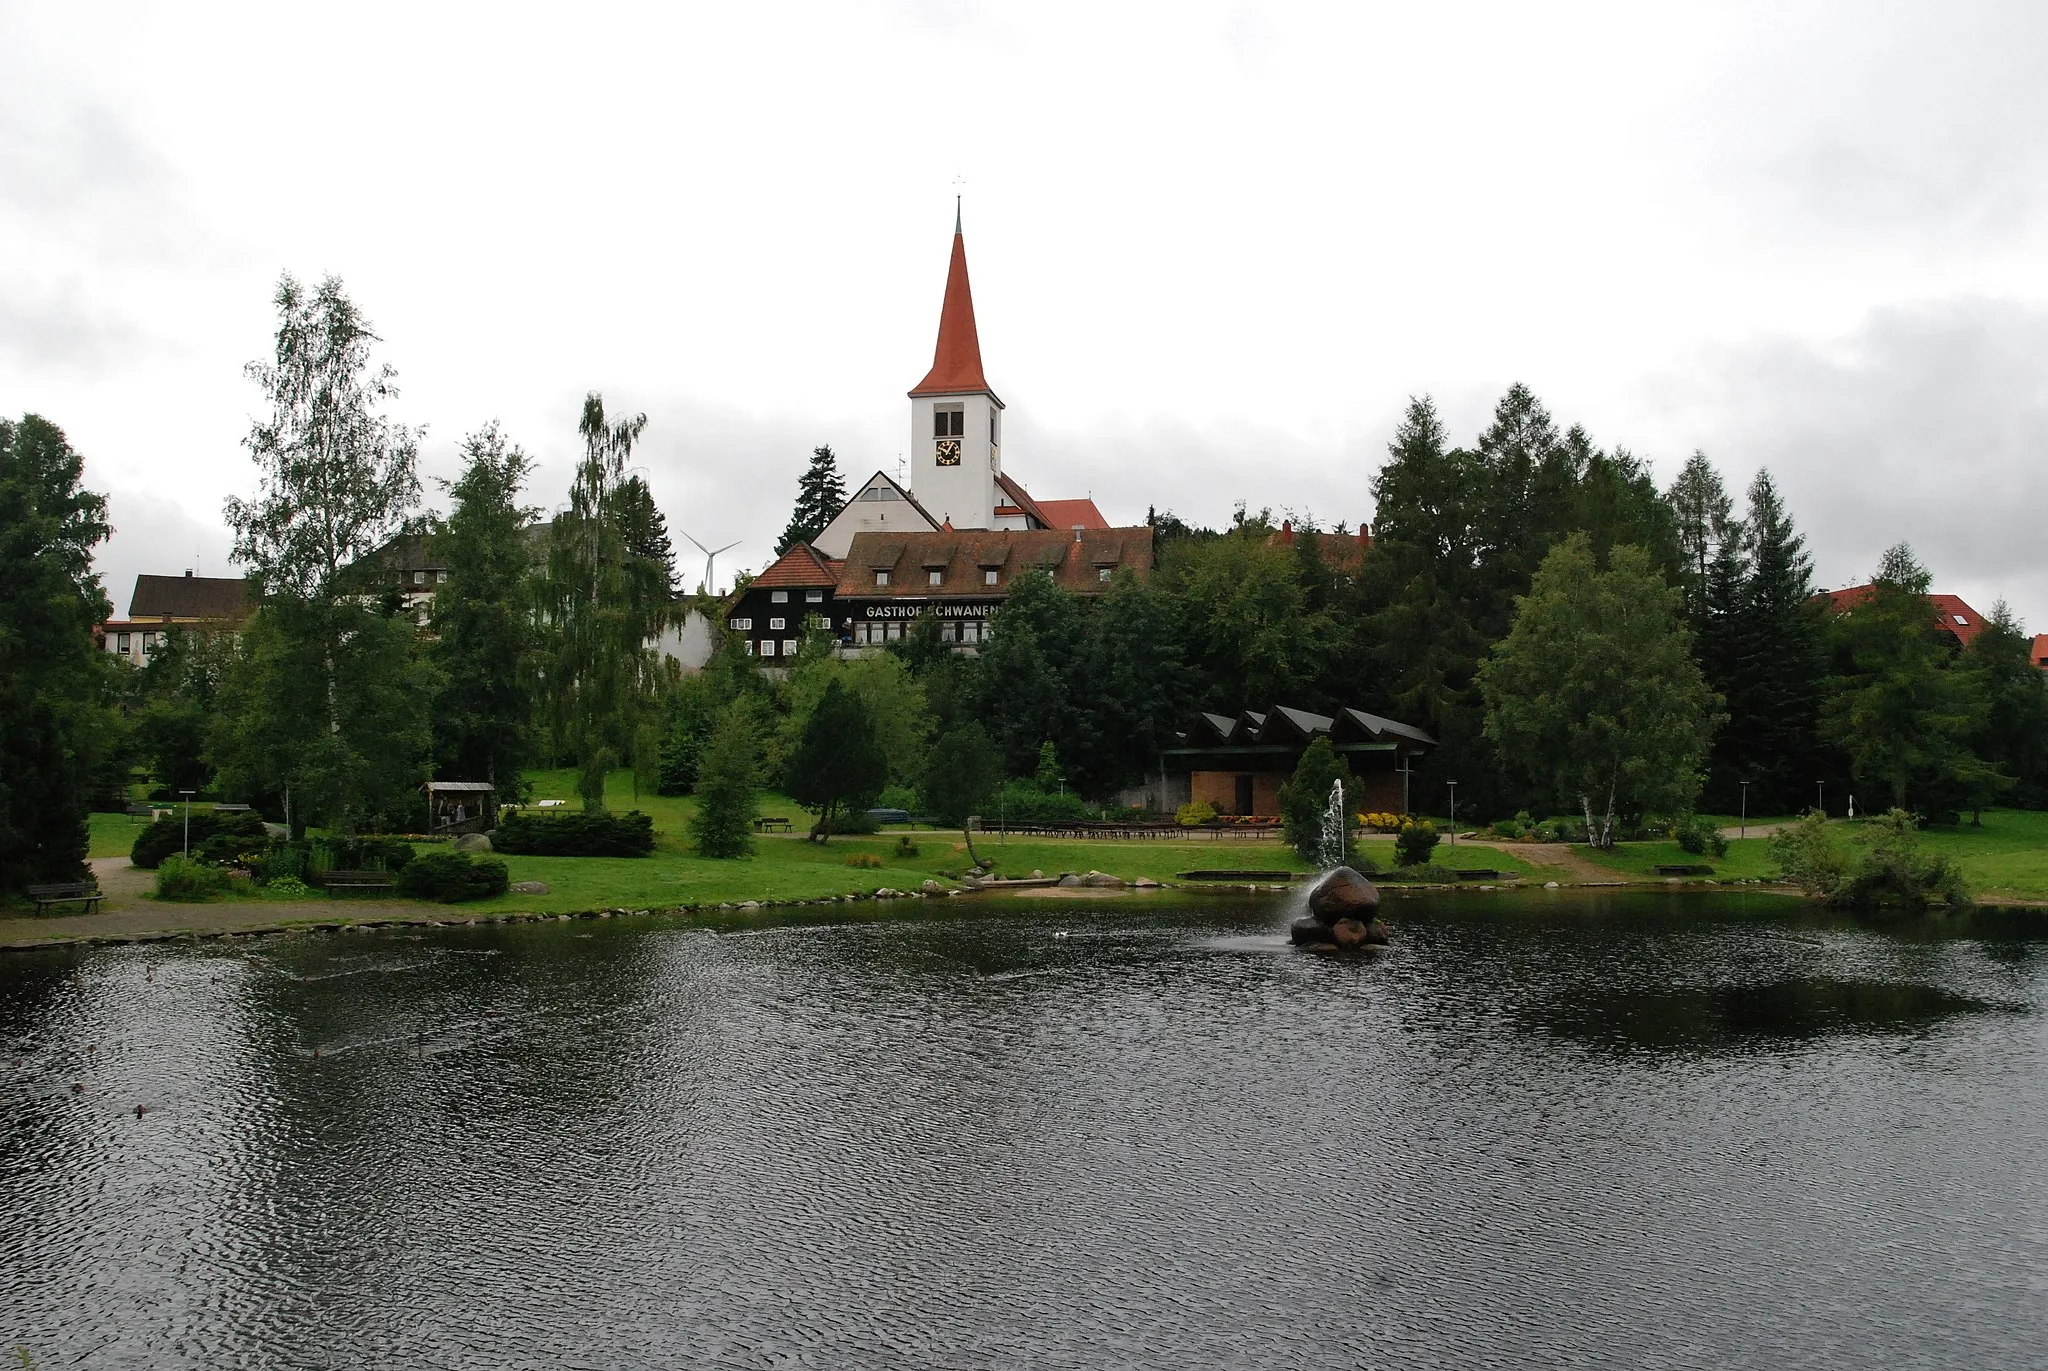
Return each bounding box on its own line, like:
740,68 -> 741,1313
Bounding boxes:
0,414 -> 111,896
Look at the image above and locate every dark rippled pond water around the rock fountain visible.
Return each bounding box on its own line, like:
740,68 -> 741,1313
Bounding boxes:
0,891 -> 2048,1371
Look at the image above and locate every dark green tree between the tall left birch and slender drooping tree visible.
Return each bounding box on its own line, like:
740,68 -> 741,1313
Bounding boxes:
432,424 -> 537,801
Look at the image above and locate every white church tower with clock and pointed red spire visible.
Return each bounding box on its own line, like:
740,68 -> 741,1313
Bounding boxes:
909,203 -> 1004,529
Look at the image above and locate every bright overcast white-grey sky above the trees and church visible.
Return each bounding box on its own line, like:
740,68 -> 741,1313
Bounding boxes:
0,0 -> 2048,629
